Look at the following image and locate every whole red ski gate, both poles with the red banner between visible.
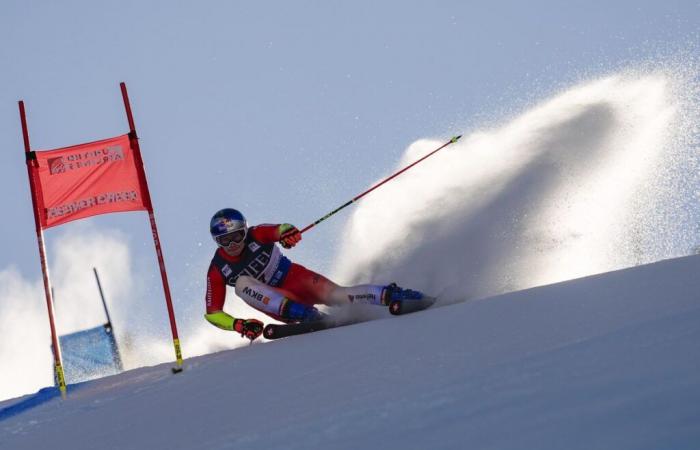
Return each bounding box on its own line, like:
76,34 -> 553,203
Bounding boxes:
18,82 -> 183,397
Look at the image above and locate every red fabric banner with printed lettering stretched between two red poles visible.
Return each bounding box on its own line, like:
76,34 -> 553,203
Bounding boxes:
29,134 -> 148,228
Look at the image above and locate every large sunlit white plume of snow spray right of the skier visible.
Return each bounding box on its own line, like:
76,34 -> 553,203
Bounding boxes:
334,65 -> 700,303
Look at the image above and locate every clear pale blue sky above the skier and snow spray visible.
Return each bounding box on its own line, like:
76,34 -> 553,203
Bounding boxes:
0,1 -> 700,312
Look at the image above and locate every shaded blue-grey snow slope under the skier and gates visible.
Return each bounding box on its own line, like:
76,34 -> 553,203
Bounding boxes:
0,256 -> 700,450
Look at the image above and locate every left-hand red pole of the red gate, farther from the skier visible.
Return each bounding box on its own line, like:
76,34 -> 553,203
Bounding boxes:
19,100 -> 67,398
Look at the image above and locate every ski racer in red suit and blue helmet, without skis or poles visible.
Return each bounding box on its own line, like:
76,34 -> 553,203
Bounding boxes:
204,208 -> 423,340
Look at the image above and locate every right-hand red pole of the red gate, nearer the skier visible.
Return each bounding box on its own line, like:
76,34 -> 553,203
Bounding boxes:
119,82 -> 182,373
